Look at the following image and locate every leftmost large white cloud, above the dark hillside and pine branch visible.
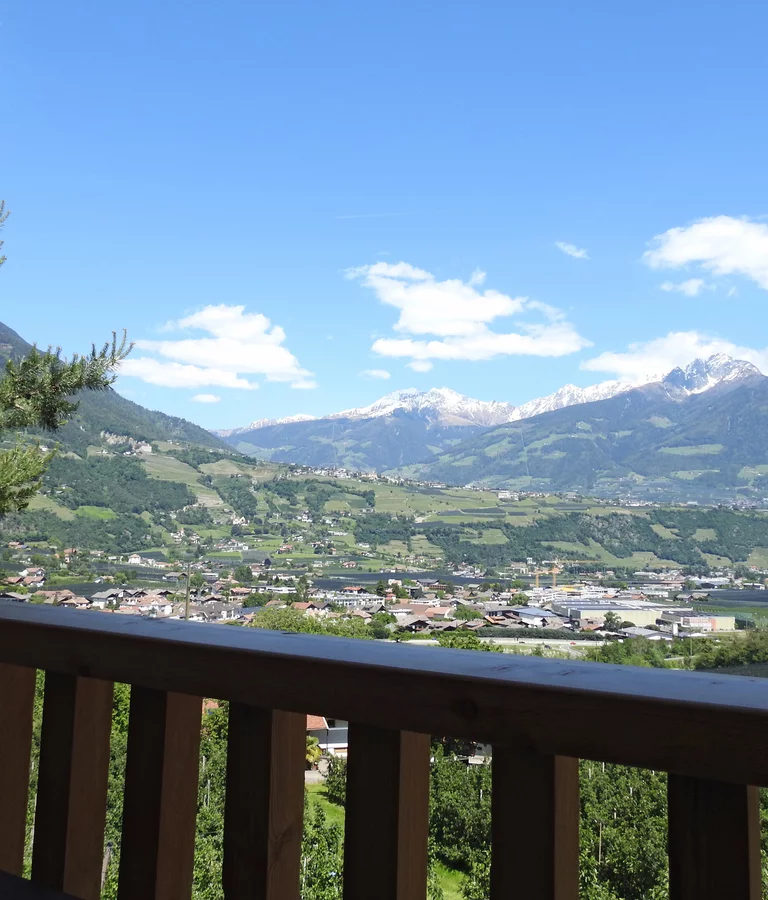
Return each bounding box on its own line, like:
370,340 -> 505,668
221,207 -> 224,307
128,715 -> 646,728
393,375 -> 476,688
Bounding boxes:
122,304 -> 314,389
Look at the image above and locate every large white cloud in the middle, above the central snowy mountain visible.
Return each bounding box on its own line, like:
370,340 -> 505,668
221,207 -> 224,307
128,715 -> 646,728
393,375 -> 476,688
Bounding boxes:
346,262 -> 590,371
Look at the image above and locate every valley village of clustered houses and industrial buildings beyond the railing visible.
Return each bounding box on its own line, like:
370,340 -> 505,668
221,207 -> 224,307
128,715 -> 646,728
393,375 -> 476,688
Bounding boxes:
0,547 -> 744,644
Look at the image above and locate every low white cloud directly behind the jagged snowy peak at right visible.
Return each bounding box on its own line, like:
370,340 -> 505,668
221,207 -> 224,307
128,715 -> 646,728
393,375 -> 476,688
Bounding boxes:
581,331 -> 768,383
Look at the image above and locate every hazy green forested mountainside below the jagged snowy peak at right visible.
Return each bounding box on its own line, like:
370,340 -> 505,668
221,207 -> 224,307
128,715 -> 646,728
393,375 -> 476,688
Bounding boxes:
402,375 -> 768,502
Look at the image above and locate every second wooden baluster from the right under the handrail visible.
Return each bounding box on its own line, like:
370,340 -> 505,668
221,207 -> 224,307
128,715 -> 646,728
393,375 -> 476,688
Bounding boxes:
491,747 -> 579,900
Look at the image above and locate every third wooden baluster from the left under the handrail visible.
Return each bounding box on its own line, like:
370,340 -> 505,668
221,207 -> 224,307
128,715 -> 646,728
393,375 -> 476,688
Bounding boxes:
118,686 -> 203,900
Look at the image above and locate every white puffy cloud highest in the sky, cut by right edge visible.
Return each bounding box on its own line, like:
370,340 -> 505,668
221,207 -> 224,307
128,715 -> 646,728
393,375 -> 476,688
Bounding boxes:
643,216 -> 768,290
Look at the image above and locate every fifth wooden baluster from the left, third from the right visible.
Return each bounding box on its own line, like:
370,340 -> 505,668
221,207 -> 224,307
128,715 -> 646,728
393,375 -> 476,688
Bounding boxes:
344,724 -> 429,900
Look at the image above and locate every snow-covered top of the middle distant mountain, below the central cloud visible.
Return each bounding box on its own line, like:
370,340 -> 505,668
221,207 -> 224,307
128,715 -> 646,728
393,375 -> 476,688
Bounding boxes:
328,388 -> 515,427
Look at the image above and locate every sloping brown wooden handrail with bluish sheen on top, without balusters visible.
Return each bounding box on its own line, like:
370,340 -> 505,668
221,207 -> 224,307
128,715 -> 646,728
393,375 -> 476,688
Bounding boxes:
0,602 -> 768,785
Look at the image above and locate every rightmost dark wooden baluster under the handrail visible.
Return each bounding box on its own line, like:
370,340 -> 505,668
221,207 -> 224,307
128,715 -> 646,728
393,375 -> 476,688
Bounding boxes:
668,775 -> 761,900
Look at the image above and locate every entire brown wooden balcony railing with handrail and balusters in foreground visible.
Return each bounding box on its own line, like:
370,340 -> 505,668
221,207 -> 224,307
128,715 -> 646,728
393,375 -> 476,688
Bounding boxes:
0,604 -> 768,900
